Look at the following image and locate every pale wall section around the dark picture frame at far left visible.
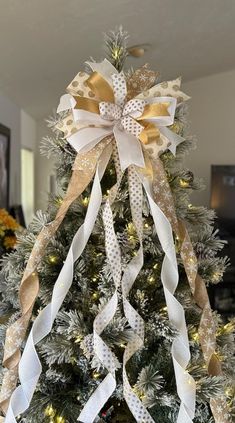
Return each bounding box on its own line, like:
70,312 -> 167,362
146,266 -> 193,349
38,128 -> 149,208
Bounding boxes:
0,94 -> 21,205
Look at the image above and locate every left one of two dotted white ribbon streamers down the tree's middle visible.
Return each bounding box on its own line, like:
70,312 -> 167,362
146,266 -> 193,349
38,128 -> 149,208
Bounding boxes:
78,146 -> 122,423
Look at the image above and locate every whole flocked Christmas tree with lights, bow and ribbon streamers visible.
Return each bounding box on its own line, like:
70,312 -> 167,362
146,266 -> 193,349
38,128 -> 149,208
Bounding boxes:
0,29 -> 235,423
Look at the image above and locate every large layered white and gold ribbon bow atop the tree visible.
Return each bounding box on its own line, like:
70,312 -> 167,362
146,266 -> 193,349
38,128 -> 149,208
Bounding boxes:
57,60 -> 182,170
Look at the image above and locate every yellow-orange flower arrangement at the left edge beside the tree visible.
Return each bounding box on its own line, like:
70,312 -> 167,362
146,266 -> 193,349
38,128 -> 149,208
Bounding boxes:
0,209 -> 20,257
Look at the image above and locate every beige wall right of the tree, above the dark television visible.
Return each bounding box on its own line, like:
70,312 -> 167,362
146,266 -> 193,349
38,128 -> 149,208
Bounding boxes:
183,70 -> 235,206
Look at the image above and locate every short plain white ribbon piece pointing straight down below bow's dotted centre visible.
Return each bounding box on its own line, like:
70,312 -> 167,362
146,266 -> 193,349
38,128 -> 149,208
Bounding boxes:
113,125 -> 145,171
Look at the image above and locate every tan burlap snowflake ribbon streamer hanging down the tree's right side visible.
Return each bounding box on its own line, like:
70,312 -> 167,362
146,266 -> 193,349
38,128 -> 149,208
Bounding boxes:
152,158 -> 231,423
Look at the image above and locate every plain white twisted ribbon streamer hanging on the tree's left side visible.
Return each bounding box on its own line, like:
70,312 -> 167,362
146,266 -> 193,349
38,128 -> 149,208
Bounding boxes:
5,146 -> 111,423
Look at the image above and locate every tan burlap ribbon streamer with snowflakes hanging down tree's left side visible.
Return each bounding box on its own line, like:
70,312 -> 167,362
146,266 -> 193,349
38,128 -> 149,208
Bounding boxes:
0,137 -> 111,413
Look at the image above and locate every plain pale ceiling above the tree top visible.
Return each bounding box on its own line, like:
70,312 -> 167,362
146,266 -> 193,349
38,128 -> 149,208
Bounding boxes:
0,0 -> 235,119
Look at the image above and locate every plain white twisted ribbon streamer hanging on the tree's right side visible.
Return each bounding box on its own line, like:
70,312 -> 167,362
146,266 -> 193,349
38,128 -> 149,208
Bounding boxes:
139,174 -> 196,423
